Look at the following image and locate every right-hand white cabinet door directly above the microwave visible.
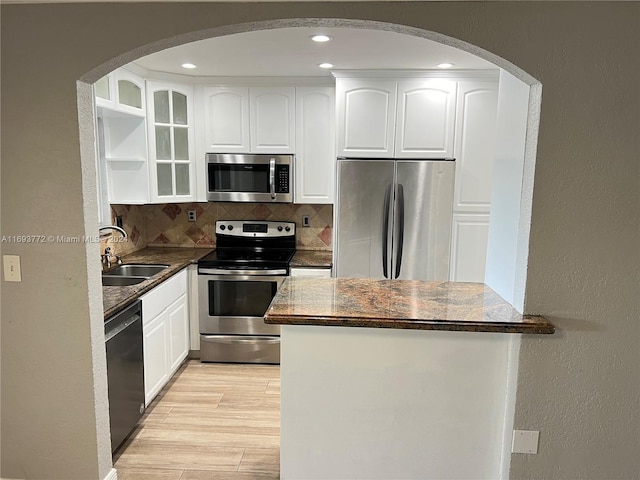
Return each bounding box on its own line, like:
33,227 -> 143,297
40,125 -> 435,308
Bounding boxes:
249,87 -> 296,153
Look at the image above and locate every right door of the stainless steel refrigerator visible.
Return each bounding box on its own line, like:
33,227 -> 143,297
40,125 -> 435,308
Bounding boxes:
392,161 -> 455,281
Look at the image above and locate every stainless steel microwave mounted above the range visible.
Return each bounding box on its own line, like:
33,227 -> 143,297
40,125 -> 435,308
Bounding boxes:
207,153 -> 294,203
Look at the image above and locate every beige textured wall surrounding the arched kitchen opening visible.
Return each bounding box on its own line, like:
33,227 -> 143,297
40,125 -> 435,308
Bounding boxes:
0,2 -> 640,479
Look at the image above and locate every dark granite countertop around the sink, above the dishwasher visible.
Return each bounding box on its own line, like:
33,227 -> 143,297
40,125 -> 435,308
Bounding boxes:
102,247 -> 213,319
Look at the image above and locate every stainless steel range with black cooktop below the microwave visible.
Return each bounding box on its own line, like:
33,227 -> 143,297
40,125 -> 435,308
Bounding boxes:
198,220 -> 296,363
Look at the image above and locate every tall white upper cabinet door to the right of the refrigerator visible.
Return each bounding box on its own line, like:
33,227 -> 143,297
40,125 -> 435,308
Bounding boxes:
454,81 -> 498,213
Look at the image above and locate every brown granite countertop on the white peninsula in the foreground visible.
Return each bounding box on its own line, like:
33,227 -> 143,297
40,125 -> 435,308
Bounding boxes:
265,277 -> 555,334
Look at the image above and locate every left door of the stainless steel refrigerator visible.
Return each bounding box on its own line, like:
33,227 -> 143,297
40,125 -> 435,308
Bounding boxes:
336,160 -> 394,278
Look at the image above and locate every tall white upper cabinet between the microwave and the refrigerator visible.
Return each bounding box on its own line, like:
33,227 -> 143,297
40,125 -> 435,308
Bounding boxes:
294,87 -> 336,204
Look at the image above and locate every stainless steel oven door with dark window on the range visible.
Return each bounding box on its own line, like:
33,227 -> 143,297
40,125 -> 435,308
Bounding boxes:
198,269 -> 286,335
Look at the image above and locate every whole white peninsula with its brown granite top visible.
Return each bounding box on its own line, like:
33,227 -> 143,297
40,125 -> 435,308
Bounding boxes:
265,277 -> 554,480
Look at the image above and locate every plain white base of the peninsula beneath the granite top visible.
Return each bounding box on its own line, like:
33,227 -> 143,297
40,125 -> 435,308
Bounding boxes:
280,325 -> 520,480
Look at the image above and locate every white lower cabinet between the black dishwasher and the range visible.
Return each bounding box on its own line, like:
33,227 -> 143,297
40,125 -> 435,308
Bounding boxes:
142,270 -> 189,406
